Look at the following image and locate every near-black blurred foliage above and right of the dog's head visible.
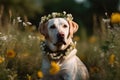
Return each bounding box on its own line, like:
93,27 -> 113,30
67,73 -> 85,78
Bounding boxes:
40,0 -> 119,35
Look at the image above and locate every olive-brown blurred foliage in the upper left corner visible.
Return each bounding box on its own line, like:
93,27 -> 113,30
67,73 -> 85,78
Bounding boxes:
0,0 -> 43,26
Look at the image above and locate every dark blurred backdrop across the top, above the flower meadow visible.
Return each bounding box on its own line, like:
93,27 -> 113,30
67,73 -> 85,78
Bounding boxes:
0,0 -> 120,35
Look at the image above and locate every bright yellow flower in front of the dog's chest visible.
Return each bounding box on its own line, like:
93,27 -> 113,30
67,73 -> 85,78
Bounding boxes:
49,61 -> 60,75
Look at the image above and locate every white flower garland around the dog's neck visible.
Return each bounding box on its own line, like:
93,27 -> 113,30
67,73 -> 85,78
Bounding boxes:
41,42 -> 76,61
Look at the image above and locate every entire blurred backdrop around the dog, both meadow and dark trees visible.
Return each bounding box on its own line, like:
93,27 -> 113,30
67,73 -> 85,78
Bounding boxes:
0,0 -> 120,80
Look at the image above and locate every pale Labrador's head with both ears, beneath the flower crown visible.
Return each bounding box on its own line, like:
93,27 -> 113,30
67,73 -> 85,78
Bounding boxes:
39,18 -> 78,51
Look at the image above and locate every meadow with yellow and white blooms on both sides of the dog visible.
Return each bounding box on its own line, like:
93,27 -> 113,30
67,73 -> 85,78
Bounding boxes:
0,13 -> 120,80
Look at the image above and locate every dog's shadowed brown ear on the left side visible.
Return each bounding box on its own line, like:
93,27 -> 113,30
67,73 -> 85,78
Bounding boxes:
38,23 -> 48,38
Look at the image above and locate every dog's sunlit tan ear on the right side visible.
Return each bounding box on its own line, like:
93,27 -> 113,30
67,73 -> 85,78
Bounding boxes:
68,20 -> 79,37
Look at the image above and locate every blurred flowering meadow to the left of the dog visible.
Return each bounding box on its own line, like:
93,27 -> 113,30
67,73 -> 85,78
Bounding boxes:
0,21 -> 42,80
